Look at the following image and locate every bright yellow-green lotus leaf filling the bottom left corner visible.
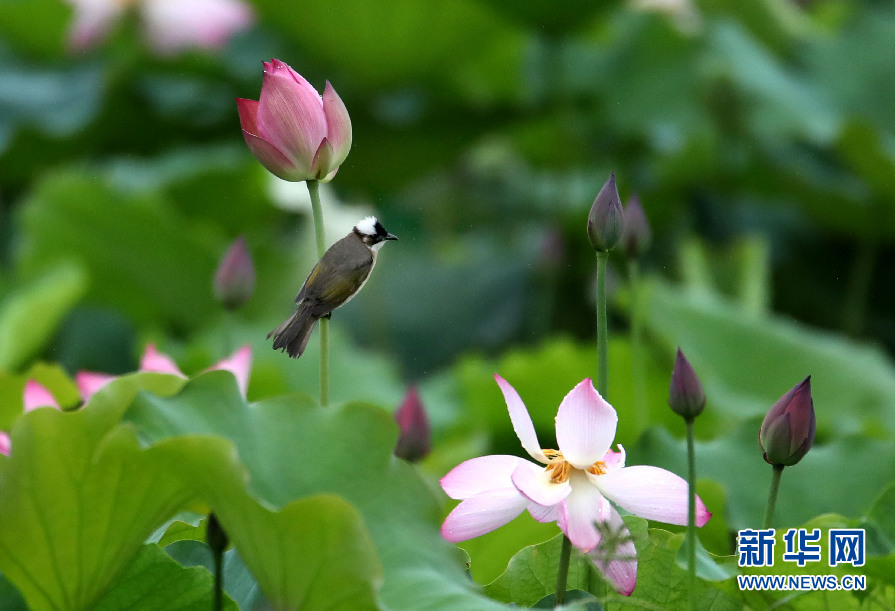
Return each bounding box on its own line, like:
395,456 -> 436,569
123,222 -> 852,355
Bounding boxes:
0,382 -> 192,609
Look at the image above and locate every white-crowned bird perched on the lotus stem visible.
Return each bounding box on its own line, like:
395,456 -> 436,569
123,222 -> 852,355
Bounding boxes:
267,216 -> 398,359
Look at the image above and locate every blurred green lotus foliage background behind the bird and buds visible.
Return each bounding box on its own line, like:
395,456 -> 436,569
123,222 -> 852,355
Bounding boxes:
0,0 -> 895,575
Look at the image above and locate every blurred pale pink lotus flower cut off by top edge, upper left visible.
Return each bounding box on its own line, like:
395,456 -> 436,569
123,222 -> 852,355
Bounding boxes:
68,0 -> 254,55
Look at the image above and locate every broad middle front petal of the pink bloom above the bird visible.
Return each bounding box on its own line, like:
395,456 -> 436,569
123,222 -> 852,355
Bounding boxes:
257,59 -> 326,179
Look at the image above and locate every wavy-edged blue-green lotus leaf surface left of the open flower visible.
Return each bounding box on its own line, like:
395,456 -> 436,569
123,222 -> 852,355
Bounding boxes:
127,372 -> 508,609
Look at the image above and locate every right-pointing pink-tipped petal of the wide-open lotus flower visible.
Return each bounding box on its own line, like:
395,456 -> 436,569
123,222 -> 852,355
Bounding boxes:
587,465 -> 712,526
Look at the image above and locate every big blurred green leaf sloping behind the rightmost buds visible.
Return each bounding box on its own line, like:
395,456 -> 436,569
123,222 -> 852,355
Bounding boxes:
649,283 -> 895,438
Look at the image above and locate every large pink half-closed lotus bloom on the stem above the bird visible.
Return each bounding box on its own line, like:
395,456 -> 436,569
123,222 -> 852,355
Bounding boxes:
236,59 -> 351,182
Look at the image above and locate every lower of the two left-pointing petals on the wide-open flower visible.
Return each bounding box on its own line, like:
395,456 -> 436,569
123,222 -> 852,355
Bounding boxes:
441,488 -> 528,543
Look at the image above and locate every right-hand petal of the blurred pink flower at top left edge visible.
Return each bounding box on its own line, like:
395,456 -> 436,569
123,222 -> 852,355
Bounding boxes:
140,0 -> 254,54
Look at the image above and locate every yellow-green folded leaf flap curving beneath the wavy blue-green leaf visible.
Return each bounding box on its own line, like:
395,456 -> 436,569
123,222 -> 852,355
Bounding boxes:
148,438 -> 382,611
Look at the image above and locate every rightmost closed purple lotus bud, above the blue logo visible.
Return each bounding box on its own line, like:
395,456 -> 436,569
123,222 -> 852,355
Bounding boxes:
758,376 -> 817,467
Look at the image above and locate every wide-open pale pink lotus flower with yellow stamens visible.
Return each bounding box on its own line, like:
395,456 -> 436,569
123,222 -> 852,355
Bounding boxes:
441,375 -> 711,595
